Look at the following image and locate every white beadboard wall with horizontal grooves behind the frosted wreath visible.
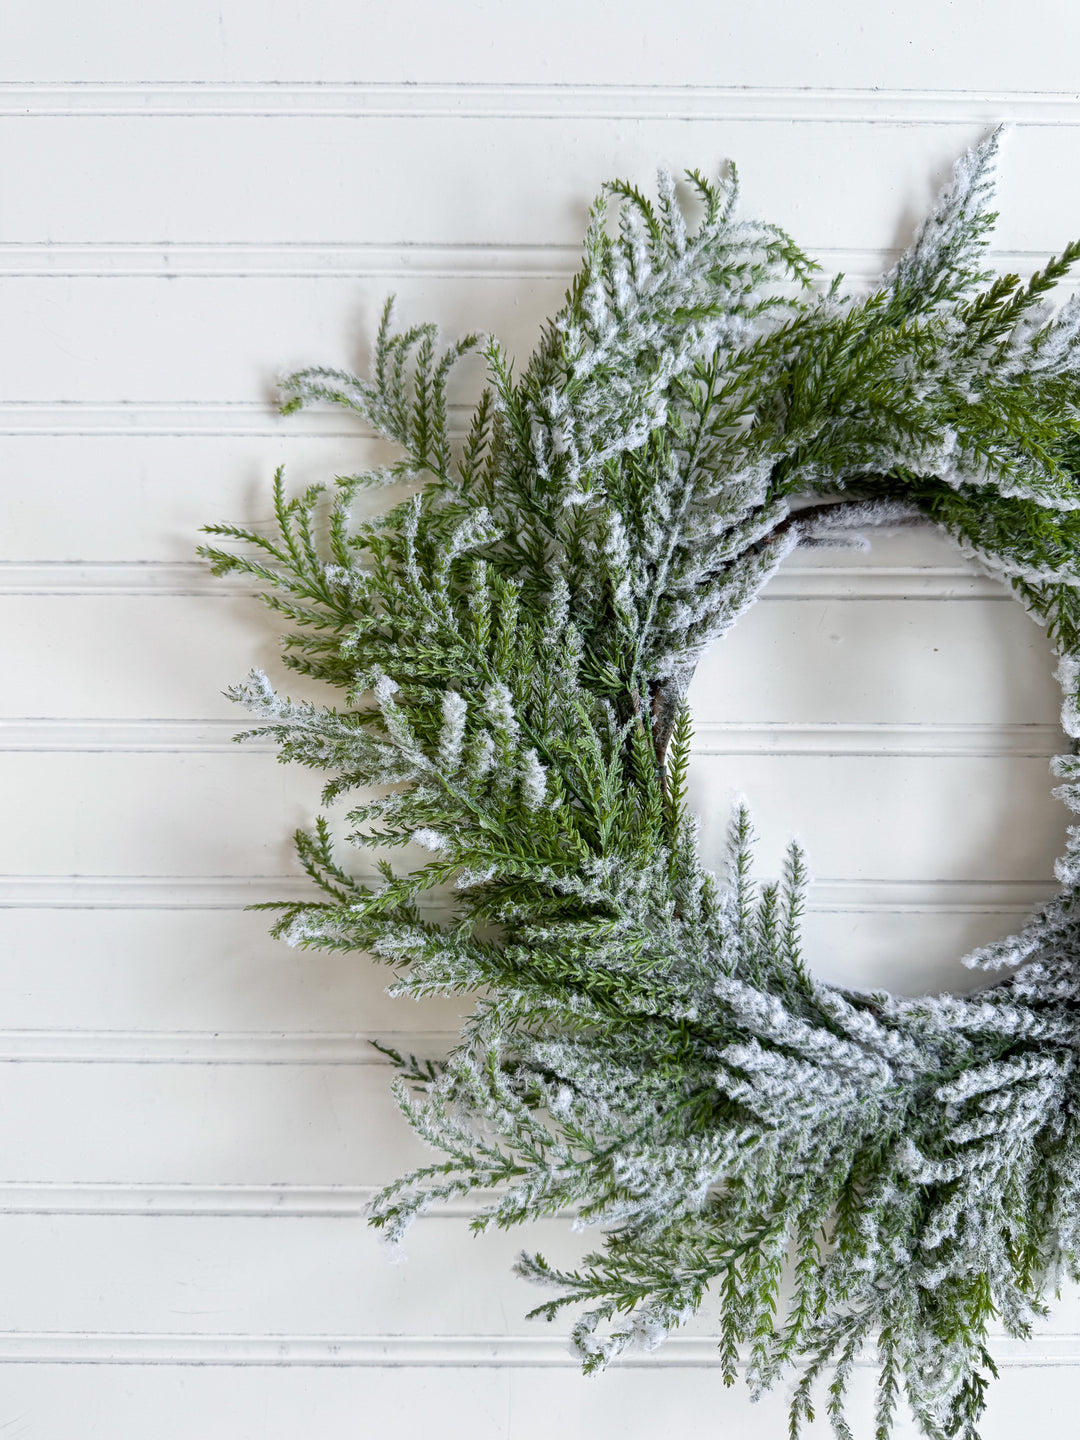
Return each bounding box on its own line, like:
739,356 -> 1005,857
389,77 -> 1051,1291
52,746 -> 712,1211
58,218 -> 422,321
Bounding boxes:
0,0 -> 1080,1440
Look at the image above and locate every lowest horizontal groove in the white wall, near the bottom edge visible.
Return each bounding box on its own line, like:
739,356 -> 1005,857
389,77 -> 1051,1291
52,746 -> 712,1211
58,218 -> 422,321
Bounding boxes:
0,1326 -> 1080,1369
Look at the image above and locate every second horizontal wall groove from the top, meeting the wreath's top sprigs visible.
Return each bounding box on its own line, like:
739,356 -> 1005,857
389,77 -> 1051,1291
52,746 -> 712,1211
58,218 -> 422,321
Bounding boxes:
0,240 -> 1079,275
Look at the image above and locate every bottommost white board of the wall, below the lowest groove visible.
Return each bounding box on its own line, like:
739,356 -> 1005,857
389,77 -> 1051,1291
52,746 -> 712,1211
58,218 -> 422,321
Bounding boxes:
7,1365 -> 1080,1440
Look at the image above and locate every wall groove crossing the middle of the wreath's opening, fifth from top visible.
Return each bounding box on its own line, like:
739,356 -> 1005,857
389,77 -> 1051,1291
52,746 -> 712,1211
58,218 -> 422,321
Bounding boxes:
0,714 -> 1067,759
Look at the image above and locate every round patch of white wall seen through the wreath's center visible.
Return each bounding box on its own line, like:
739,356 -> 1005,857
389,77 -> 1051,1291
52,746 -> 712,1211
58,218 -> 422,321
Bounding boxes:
687,523 -> 1067,995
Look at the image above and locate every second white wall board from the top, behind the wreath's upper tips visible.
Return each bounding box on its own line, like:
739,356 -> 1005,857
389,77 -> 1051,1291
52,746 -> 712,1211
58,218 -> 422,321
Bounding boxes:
0,120 -> 1077,253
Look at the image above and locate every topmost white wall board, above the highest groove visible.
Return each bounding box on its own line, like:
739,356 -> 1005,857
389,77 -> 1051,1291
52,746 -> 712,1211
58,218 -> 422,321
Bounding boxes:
0,0 -> 1076,89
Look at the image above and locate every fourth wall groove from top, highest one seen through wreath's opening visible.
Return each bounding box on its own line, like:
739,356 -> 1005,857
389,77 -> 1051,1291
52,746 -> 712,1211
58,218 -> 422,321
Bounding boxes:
0,560 -> 1012,600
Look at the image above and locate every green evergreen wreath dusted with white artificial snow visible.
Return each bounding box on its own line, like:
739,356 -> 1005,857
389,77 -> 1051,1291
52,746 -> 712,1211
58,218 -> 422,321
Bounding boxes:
202,132 -> 1080,1440
